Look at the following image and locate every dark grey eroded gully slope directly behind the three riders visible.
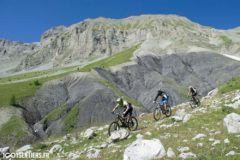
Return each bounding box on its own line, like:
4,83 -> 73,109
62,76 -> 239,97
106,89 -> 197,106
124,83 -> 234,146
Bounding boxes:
0,52 -> 236,144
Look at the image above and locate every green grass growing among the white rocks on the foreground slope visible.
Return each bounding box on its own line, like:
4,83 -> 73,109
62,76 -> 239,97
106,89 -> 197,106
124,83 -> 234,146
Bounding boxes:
30,89 -> 240,160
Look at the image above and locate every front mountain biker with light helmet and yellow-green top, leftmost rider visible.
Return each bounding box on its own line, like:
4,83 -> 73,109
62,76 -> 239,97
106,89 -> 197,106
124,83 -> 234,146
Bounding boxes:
112,98 -> 133,121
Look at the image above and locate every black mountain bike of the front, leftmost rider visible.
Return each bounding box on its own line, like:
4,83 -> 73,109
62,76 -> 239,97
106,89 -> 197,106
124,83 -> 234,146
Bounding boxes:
108,112 -> 138,136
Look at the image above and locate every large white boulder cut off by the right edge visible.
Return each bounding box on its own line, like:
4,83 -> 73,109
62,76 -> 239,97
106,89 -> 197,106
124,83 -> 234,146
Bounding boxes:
223,113 -> 240,133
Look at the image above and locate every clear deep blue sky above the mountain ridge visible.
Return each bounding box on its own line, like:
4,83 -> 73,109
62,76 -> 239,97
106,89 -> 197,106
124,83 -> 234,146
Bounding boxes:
0,0 -> 240,42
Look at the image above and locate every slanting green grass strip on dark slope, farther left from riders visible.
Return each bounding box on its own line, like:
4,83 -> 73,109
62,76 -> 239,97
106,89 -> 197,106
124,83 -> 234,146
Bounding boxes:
41,104 -> 67,122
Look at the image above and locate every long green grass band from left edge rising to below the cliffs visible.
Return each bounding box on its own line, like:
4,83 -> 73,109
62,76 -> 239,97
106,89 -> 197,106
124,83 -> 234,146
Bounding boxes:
0,45 -> 139,106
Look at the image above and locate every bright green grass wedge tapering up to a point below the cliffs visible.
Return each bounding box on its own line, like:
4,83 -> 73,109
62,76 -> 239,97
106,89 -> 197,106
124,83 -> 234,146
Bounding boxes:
80,45 -> 139,72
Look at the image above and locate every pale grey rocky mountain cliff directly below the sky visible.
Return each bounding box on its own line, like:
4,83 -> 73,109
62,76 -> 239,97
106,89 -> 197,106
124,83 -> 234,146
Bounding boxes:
0,15 -> 240,74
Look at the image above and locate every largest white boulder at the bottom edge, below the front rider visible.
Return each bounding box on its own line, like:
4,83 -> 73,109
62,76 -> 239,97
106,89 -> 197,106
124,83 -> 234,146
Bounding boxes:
123,139 -> 166,160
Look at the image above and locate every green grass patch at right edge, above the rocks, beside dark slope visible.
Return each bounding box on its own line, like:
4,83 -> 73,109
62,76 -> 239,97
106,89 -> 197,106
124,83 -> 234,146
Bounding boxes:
218,77 -> 240,94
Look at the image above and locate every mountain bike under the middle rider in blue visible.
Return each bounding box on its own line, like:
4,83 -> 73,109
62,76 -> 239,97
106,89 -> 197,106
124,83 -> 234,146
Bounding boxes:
153,102 -> 172,121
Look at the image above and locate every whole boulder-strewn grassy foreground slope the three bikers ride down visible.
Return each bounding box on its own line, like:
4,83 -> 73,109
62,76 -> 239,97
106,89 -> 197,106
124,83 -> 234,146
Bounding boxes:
1,90 -> 240,160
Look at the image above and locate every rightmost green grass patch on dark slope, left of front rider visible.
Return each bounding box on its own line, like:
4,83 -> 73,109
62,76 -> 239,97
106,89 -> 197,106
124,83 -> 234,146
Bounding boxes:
64,106 -> 80,132
